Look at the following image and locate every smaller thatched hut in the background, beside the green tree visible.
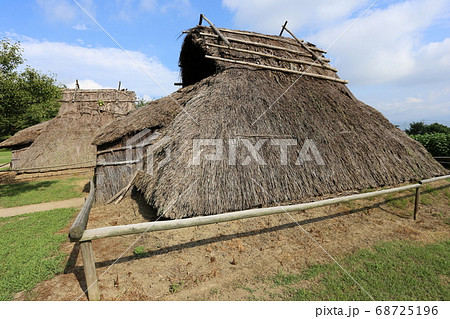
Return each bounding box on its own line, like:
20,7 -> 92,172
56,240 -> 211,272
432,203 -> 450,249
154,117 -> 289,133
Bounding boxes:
0,89 -> 135,173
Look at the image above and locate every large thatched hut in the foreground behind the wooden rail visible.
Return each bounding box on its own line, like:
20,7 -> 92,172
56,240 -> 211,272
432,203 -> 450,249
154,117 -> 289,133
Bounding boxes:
94,27 -> 445,218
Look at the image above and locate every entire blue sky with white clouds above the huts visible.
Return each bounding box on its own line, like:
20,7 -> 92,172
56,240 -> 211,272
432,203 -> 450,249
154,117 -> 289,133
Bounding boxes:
0,0 -> 450,128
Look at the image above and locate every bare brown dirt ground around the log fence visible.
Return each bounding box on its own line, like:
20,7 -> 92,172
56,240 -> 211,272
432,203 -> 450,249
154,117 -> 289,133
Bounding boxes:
16,181 -> 450,300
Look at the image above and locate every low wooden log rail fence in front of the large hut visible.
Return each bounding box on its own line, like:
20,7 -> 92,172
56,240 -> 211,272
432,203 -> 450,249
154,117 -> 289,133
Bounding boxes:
69,175 -> 450,300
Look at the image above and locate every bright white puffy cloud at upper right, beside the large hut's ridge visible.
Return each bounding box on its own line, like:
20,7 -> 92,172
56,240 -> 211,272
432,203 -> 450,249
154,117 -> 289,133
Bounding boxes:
312,0 -> 447,84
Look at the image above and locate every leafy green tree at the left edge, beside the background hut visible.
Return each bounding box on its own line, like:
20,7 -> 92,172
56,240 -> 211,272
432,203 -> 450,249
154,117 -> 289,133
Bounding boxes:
0,38 -> 62,141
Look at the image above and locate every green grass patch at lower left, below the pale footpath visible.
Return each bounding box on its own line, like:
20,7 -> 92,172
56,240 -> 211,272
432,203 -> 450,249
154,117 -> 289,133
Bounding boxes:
0,208 -> 76,300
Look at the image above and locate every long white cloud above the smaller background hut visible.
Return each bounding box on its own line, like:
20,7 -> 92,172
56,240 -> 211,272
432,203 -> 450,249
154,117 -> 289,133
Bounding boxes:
21,40 -> 178,97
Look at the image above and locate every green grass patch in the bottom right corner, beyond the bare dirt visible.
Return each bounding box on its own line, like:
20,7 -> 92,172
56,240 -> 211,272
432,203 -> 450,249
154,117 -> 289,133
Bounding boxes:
272,241 -> 450,300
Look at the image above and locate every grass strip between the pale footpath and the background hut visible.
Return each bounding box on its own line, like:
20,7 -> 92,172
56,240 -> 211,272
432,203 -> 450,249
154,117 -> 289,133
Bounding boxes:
0,177 -> 84,207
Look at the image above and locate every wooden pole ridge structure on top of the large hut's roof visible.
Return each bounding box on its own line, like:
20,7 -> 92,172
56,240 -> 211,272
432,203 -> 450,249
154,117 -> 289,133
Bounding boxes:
184,14 -> 348,84
